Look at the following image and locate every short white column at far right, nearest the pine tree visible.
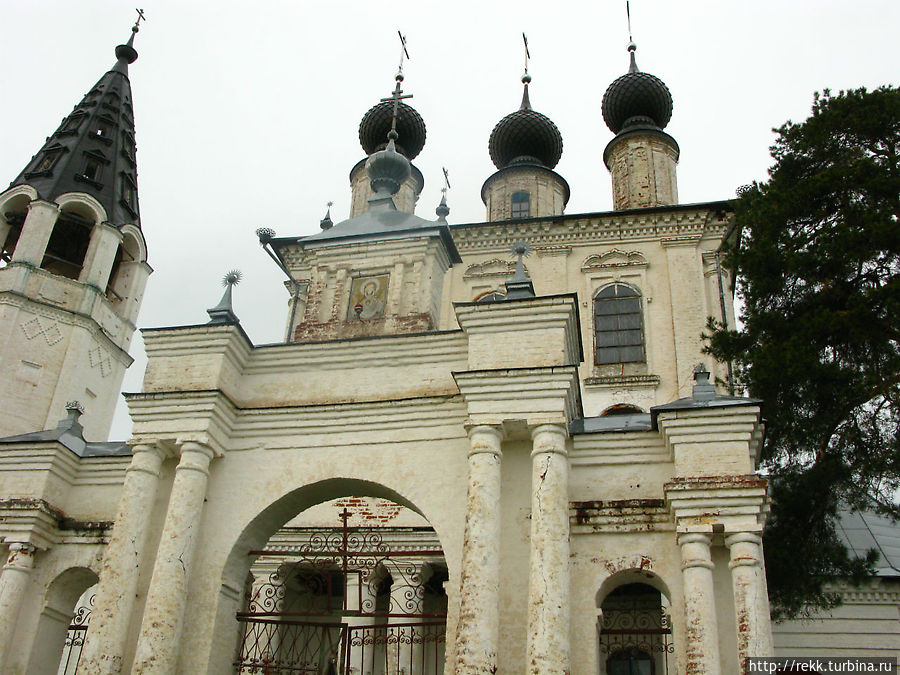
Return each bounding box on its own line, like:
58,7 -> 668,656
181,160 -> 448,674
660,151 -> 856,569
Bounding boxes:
725,532 -> 773,668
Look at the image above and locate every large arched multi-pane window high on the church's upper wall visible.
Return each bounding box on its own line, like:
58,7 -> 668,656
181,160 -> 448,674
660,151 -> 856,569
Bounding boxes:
594,284 -> 645,365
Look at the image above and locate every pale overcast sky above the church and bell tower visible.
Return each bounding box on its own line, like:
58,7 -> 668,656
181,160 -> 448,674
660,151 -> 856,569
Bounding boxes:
0,0 -> 900,439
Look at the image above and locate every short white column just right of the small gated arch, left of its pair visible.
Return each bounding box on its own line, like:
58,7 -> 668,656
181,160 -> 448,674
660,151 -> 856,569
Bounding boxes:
678,533 -> 722,675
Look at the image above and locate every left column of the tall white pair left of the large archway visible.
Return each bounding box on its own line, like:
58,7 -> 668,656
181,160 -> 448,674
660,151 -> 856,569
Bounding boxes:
79,445 -> 163,675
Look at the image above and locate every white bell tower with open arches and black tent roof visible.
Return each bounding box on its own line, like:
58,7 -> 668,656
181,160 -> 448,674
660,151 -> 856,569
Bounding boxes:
0,21 -> 152,440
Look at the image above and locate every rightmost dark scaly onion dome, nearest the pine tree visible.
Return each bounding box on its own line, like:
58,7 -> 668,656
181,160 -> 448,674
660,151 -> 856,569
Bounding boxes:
601,42 -> 672,134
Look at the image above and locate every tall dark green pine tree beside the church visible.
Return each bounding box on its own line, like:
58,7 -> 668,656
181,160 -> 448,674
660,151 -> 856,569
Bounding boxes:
708,87 -> 900,617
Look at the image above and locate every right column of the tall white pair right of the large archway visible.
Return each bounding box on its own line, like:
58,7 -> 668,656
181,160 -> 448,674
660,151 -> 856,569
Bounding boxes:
526,424 -> 569,675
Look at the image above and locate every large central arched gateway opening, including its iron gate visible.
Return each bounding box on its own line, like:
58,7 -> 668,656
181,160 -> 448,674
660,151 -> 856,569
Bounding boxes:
211,478 -> 448,675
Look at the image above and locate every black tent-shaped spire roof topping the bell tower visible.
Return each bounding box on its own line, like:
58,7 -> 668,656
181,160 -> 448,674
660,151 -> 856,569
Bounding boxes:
10,10 -> 145,226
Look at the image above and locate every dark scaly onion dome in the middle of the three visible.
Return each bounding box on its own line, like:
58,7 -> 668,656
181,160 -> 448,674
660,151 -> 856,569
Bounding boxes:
488,74 -> 562,169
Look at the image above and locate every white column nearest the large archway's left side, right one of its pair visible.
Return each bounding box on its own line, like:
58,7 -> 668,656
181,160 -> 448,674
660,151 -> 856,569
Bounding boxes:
132,442 -> 213,675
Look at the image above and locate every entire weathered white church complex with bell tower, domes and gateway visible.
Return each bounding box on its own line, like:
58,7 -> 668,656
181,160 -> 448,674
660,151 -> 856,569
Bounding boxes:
0,18 -> 900,675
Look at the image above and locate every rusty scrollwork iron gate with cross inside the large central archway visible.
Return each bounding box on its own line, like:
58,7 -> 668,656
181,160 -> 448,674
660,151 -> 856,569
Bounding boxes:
234,509 -> 446,675
